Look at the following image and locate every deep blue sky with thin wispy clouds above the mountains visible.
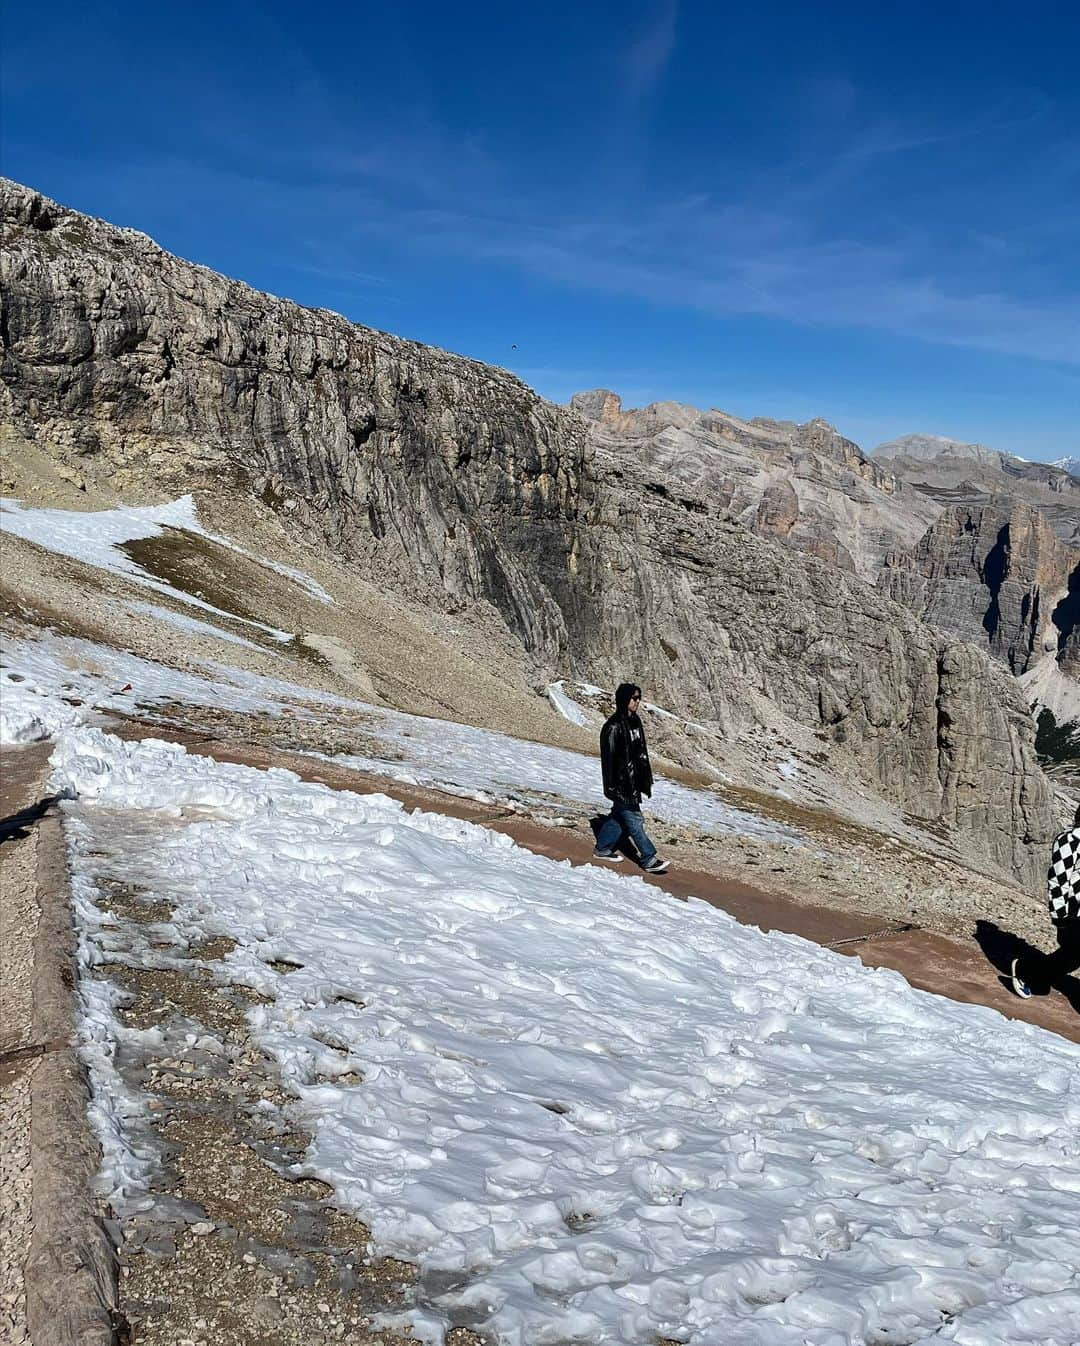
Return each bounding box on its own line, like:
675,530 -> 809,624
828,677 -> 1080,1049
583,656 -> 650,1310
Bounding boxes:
0,0 -> 1080,459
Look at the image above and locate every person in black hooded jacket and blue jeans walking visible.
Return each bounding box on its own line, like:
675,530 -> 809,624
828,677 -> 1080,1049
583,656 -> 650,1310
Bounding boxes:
593,682 -> 668,874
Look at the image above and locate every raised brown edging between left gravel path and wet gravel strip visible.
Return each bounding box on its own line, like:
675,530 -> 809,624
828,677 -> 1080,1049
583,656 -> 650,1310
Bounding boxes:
24,813 -> 120,1346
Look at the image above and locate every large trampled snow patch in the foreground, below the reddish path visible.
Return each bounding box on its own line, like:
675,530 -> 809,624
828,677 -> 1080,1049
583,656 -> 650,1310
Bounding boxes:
53,728 -> 1080,1346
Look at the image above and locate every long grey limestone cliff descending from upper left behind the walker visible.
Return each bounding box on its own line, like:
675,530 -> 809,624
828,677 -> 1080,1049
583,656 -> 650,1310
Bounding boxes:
1,183 -> 1053,887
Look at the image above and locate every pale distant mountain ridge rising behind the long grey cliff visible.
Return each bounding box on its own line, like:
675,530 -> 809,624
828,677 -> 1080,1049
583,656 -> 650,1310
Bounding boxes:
571,389 -> 940,580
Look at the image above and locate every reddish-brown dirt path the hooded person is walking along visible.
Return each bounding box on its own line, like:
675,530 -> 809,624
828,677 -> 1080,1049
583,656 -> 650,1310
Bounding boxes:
116,720 -> 1080,1042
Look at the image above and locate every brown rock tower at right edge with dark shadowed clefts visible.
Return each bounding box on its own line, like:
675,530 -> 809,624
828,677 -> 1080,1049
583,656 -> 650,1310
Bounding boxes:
878,501 -> 1080,676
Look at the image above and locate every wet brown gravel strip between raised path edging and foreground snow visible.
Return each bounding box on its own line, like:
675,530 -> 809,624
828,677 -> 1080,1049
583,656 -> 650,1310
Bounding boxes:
75,812 -> 479,1346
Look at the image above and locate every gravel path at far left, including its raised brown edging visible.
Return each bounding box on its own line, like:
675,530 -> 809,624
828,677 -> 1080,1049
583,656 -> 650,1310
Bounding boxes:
0,744 -> 119,1346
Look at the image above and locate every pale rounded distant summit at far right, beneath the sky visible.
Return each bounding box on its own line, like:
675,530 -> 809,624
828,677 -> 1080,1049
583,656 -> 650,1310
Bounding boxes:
871,435 -> 1080,546
